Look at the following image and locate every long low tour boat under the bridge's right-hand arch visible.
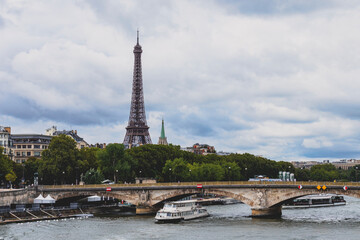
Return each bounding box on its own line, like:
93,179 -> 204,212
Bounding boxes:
283,194 -> 346,208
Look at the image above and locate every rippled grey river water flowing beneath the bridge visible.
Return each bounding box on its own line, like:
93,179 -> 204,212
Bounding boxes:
0,197 -> 360,240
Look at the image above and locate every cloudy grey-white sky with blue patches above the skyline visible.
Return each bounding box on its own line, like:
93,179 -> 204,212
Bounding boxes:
0,0 -> 360,161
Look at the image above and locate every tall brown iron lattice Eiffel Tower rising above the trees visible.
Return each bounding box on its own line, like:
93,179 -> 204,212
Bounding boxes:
123,30 -> 152,148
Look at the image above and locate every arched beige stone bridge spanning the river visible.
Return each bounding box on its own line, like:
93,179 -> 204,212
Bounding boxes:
0,182 -> 360,216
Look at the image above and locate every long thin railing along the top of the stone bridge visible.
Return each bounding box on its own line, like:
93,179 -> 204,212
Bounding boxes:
39,181 -> 360,189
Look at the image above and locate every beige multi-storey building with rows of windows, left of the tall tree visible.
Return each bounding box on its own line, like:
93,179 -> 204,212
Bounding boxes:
11,134 -> 52,163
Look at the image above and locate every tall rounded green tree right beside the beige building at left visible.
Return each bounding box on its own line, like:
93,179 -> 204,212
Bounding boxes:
39,134 -> 79,184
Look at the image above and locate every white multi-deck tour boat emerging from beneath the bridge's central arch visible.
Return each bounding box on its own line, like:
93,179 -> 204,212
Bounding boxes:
155,200 -> 209,223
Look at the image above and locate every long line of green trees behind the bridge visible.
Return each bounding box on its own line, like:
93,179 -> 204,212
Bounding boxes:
0,135 -> 360,184
